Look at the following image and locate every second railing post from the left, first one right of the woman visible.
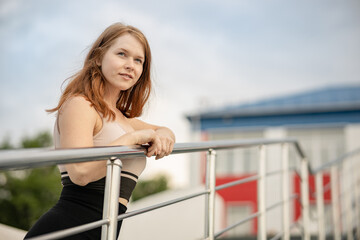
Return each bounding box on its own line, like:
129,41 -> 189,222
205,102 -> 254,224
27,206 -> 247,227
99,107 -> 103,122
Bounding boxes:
207,149 -> 216,240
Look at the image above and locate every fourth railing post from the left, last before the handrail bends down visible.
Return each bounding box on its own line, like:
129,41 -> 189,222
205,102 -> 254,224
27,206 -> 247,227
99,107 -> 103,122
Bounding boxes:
282,143 -> 290,240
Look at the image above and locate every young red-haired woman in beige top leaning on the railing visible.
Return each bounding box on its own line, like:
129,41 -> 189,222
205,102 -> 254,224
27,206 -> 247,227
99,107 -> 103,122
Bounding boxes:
25,23 -> 175,239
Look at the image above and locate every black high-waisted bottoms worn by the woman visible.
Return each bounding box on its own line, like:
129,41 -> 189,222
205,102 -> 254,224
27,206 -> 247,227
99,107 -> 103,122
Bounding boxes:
25,185 -> 126,240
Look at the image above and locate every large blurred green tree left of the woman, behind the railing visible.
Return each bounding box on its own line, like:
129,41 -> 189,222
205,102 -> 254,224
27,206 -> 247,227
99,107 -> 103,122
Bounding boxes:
0,131 -> 61,230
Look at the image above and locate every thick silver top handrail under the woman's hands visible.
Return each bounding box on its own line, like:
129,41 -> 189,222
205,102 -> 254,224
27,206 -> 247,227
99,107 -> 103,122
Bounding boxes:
0,138 -> 305,170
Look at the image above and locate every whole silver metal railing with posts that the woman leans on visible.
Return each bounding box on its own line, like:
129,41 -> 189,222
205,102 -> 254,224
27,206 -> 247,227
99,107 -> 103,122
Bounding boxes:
0,138 -> 360,240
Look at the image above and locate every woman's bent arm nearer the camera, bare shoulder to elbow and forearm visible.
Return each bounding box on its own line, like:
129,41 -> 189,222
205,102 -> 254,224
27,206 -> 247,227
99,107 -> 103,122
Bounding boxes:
58,96 -> 171,186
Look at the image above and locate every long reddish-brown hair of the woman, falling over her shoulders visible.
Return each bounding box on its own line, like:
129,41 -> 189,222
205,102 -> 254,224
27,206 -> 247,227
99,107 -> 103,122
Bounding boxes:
46,23 -> 151,120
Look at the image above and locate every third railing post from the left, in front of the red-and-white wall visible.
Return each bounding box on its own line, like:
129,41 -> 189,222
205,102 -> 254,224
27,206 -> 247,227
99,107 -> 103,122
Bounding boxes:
257,145 -> 266,240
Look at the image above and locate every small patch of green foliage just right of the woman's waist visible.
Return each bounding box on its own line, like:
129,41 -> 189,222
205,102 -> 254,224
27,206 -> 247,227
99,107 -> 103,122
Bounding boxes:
131,175 -> 169,201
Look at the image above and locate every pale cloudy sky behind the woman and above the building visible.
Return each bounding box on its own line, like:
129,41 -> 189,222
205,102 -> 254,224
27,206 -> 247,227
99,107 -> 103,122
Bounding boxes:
0,0 -> 360,186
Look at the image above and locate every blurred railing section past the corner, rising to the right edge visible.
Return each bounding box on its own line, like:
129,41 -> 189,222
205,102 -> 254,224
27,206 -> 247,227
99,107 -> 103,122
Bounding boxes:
310,149 -> 360,240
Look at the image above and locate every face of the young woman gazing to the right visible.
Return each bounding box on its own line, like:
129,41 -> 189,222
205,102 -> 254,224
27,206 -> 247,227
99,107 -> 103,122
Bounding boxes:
101,33 -> 145,91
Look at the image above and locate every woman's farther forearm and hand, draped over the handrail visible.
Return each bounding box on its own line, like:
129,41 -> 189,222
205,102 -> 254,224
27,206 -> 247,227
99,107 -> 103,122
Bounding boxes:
129,118 -> 175,159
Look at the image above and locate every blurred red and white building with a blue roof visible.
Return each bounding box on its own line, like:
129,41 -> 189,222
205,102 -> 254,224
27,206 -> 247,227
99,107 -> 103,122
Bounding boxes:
187,85 -> 360,235
